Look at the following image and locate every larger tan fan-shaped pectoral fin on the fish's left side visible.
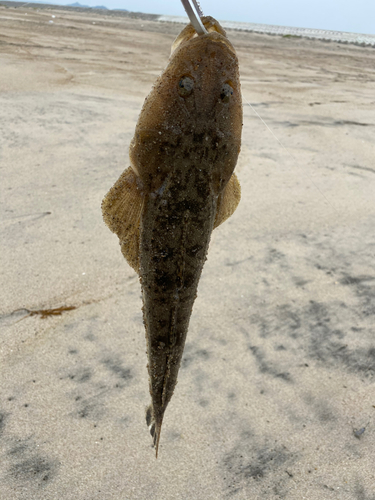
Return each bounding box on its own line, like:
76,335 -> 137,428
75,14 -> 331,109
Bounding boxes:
102,167 -> 144,273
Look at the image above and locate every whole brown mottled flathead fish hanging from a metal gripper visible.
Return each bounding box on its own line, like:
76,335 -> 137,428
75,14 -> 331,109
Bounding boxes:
102,16 -> 242,458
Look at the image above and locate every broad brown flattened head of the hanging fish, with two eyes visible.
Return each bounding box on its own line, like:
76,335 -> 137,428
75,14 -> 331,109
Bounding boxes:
130,17 -> 242,194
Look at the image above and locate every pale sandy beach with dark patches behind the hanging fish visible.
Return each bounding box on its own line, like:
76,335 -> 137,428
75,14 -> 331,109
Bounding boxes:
0,4 -> 375,500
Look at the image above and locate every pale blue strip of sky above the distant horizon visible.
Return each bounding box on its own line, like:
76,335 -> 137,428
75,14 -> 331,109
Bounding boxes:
22,0 -> 375,34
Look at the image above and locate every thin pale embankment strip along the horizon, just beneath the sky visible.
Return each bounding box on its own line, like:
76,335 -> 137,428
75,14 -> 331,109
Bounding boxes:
0,1 -> 375,47
